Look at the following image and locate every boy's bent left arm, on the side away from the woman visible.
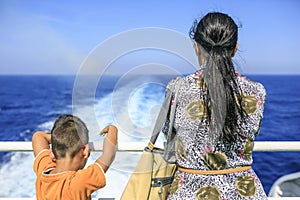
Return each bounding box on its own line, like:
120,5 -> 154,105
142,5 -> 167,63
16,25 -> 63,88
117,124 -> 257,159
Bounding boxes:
32,131 -> 51,156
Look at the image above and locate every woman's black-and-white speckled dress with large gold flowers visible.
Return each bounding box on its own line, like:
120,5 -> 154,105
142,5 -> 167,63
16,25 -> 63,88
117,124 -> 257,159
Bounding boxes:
164,70 -> 267,200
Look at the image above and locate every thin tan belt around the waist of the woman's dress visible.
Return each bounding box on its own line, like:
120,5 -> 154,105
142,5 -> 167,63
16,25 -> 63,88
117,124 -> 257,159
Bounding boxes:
178,166 -> 251,175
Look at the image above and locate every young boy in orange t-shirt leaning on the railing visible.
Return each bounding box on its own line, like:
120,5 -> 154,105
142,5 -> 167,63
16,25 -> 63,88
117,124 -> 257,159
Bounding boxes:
32,115 -> 118,200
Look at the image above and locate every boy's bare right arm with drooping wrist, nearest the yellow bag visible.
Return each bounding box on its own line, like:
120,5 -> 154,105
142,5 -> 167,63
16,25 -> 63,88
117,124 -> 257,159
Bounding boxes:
96,125 -> 118,172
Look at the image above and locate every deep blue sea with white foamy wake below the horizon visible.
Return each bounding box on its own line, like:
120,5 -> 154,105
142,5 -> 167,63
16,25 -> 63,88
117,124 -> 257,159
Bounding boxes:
0,75 -> 300,199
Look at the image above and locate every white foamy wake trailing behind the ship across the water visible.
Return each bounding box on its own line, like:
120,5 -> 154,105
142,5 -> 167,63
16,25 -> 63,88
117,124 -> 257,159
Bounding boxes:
0,79 -> 164,199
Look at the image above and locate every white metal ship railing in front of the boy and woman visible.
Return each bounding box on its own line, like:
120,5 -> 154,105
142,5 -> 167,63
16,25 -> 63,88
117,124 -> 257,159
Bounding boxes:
0,141 -> 300,200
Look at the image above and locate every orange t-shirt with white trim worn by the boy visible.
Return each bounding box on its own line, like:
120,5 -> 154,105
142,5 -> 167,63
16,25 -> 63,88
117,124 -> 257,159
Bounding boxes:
33,149 -> 106,200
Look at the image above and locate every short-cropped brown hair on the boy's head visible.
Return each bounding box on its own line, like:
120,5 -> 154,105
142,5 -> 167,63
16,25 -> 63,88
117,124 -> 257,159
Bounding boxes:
51,114 -> 89,159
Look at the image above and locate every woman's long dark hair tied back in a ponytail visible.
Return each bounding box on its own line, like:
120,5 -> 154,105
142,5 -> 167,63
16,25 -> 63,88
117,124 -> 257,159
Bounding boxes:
190,13 -> 247,143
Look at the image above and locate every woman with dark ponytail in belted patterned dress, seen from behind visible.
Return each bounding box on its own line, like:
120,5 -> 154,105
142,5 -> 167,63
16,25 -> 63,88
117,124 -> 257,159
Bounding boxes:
165,12 -> 267,200
